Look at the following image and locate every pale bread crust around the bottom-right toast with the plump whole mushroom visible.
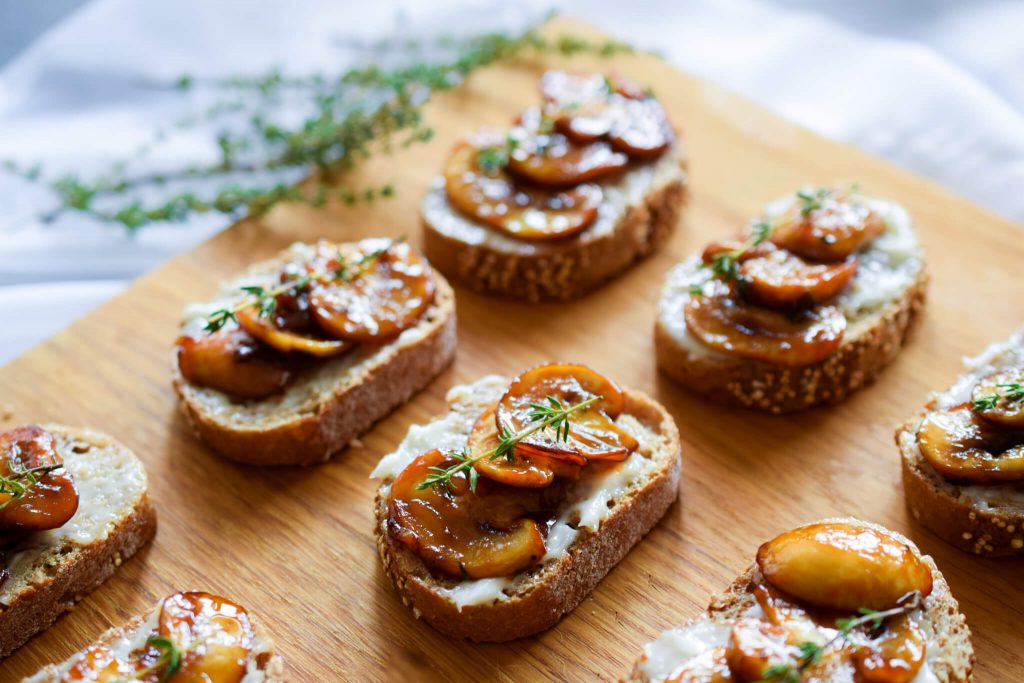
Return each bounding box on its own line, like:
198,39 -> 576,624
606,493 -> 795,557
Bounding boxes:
622,518 -> 975,683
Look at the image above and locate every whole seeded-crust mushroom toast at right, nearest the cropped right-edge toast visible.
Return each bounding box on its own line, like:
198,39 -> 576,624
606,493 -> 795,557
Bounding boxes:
654,188 -> 927,413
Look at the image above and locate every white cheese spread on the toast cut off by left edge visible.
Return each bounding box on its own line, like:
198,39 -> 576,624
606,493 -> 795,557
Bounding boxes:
0,432 -> 146,604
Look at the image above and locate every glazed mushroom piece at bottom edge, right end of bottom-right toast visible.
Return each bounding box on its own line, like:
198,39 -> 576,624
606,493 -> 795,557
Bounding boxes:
853,614 -> 927,683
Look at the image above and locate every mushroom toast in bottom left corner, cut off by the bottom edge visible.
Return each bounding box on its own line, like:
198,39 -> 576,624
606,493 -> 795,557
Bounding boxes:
24,592 -> 286,683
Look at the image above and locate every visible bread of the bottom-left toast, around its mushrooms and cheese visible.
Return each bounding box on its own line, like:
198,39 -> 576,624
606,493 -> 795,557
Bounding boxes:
22,589 -> 288,683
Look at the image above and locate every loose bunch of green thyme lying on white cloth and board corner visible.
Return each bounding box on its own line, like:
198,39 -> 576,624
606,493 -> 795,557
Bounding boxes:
0,27 -> 635,230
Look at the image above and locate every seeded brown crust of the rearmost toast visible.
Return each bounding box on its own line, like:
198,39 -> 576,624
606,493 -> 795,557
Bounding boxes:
421,157 -> 686,301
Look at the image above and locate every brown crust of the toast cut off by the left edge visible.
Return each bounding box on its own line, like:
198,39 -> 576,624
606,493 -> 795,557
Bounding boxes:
0,425 -> 157,658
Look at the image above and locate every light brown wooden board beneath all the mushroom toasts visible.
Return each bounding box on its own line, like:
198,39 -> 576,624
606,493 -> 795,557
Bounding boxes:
0,15 -> 1024,682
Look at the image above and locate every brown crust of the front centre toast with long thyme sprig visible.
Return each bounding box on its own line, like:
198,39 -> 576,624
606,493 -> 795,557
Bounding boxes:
375,391 -> 681,642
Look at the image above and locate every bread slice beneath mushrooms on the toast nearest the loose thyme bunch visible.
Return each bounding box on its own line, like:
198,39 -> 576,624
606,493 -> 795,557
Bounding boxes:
173,244 -> 456,465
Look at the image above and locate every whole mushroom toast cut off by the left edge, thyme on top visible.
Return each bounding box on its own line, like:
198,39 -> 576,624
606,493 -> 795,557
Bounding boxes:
0,425 -> 157,657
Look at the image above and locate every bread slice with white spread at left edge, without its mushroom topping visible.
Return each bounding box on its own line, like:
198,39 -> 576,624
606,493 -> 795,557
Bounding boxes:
0,425 -> 157,657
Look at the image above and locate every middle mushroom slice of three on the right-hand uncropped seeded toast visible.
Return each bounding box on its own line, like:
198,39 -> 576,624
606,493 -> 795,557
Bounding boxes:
739,250 -> 857,308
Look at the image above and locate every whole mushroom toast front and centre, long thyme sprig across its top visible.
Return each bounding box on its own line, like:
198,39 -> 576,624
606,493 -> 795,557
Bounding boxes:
372,364 -> 680,641
